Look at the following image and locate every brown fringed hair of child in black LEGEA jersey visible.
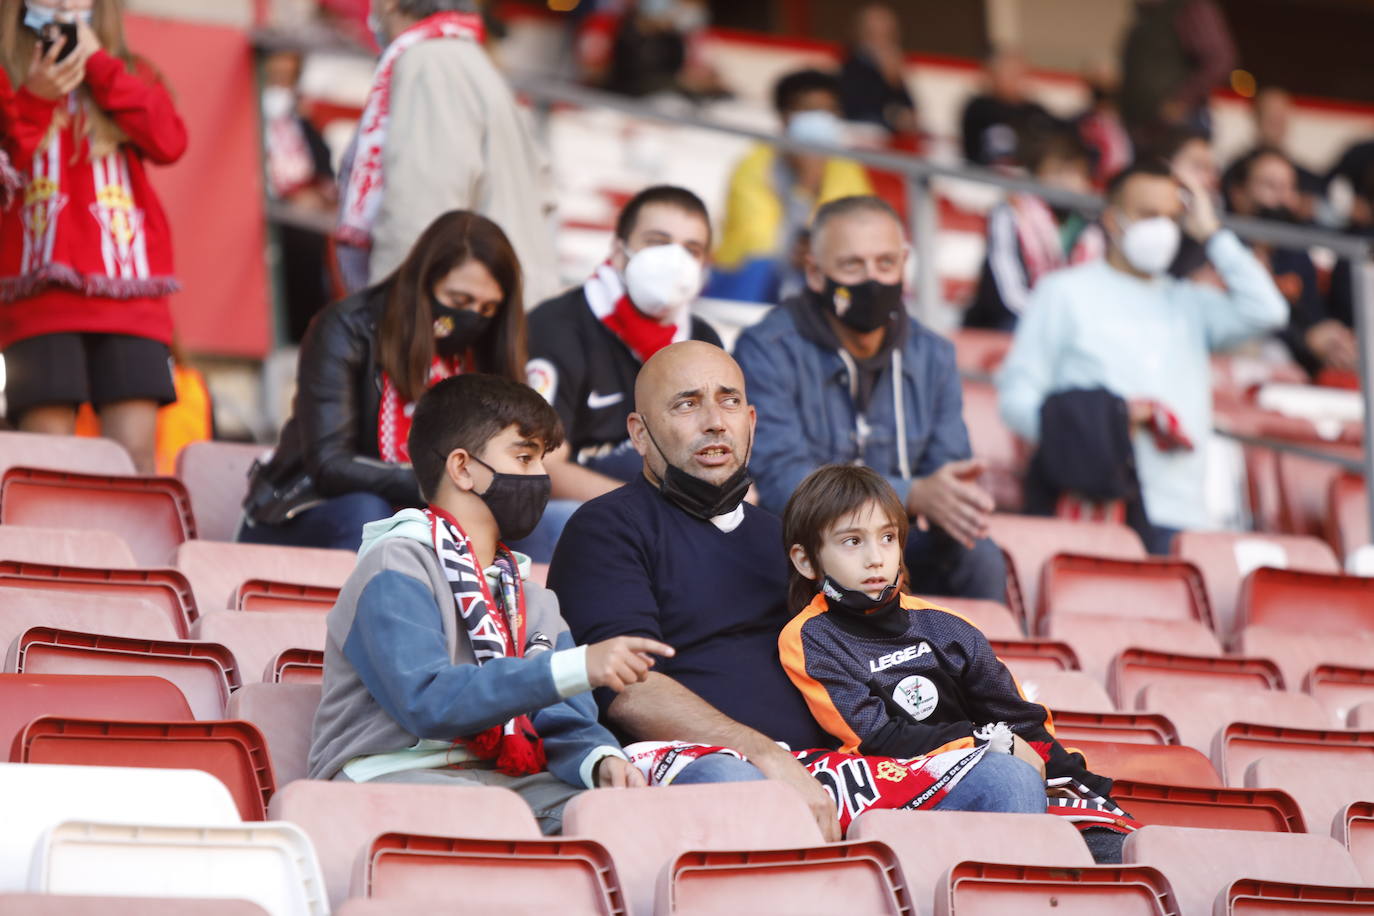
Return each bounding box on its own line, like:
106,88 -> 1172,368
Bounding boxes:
782,464 -> 911,612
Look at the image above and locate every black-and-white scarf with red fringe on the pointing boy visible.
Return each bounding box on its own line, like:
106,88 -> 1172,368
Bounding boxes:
425,508 -> 554,776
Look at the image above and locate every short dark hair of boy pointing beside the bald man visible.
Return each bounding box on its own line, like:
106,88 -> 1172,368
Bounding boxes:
408,374 -> 563,503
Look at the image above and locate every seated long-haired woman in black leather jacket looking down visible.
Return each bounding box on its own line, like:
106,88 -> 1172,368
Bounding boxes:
238,210 -> 525,549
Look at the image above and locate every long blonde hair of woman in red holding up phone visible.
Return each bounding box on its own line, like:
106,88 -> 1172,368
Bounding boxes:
0,0 -> 133,159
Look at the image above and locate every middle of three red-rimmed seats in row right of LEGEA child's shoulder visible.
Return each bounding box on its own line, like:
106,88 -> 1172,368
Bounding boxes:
1107,648 -> 1283,710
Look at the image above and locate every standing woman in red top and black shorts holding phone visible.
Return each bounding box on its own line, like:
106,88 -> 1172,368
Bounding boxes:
0,0 -> 185,472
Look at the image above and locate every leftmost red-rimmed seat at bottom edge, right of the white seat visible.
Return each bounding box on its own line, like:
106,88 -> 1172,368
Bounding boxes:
353,834 -> 625,913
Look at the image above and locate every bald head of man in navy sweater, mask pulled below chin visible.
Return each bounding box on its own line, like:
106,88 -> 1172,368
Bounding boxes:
629,341 -> 754,483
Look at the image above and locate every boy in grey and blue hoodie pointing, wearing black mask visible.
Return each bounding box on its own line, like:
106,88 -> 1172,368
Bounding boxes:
309,375 -> 673,834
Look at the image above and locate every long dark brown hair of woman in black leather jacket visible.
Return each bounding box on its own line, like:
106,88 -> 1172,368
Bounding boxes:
378,210 -> 525,402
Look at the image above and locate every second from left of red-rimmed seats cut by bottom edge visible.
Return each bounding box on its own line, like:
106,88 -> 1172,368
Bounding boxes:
654,842 -> 915,916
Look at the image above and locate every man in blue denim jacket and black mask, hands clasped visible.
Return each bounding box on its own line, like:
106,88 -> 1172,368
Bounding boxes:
735,196 -> 1006,600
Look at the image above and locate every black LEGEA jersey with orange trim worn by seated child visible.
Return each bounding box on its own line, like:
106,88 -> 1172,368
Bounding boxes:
778,593 -> 1112,795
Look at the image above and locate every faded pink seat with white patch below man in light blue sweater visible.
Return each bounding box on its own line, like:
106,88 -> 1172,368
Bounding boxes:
1172,531 -> 1341,640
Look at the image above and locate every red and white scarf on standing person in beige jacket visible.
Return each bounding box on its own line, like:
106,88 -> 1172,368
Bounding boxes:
338,12 -> 486,249
